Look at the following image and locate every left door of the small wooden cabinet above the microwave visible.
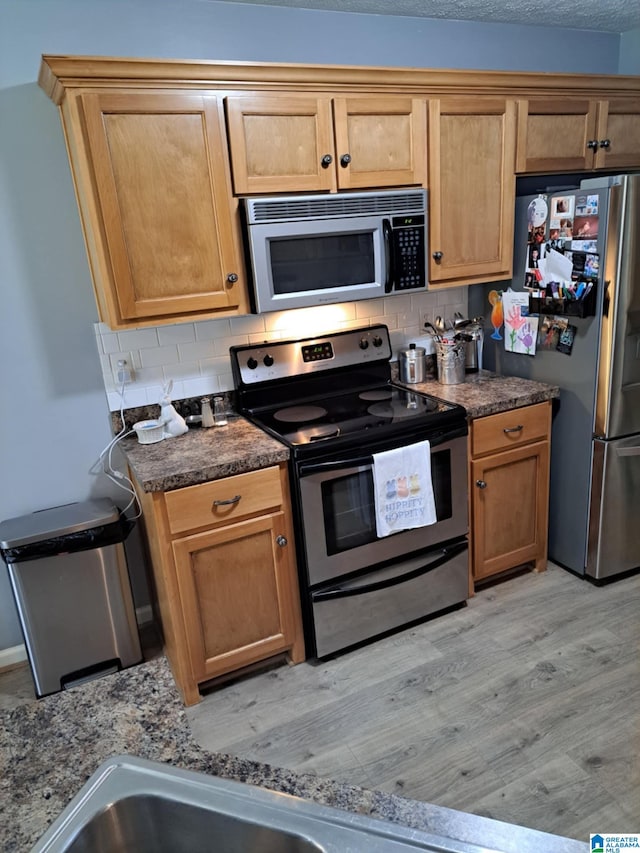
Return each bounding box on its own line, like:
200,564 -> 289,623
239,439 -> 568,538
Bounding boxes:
226,94 -> 337,195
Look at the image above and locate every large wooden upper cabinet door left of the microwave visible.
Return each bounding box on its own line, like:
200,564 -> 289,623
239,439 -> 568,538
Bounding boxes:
80,92 -> 246,328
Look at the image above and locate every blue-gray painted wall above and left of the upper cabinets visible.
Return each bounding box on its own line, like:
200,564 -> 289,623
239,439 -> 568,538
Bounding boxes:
0,0 -> 639,652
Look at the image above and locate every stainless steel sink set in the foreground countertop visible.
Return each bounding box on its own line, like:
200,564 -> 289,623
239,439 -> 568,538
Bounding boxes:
32,756 -> 496,853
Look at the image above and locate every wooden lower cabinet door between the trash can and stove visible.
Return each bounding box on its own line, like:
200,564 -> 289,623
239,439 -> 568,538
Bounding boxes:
172,512 -> 297,681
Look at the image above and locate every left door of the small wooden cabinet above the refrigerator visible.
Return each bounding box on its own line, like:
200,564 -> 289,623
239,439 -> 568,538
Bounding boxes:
516,98 -> 598,173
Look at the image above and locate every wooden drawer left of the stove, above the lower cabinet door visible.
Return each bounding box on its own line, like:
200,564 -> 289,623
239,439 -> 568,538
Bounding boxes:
165,466 -> 282,533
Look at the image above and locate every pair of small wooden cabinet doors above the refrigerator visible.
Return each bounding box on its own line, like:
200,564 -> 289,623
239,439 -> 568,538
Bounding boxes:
516,98 -> 640,173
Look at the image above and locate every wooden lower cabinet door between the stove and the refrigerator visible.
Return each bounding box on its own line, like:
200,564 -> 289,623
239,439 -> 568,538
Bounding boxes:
471,441 -> 549,580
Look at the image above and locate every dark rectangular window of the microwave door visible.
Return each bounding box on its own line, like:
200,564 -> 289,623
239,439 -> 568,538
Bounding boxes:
269,231 -> 375,295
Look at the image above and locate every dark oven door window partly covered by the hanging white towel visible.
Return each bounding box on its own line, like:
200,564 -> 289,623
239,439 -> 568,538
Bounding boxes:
322,449 -> 453,557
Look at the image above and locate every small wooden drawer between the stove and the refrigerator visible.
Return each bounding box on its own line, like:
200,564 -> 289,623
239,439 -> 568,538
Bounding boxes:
471,403 -> 551,458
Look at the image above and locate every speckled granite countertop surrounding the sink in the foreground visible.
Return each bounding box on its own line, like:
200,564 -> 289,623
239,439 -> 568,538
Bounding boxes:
0,656 -> 588,853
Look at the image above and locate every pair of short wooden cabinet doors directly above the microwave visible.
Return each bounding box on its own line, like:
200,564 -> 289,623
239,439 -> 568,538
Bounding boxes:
226,94 -> 427,195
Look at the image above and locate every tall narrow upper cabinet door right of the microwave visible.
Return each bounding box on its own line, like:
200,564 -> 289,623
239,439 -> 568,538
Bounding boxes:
429,97 -> 516,287
